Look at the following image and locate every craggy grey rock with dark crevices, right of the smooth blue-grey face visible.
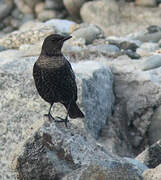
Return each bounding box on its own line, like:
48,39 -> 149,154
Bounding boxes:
101,56 -> 161,155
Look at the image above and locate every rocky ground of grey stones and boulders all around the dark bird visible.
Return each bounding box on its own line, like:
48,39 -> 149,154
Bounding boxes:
0,0 -> 161,180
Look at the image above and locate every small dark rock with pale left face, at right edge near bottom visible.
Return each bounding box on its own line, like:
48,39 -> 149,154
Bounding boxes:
136,140 -> 161,168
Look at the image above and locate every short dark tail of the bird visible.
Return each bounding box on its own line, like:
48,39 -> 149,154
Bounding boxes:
64,102 -> 84,118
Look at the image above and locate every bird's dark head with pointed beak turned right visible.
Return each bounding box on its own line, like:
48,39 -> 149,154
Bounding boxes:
41,34 -> 72,56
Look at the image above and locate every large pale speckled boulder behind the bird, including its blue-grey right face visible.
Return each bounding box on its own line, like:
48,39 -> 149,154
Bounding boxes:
0,50 -> 114,180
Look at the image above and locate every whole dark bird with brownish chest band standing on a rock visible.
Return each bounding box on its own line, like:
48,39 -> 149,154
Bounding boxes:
33,34 -> 84,127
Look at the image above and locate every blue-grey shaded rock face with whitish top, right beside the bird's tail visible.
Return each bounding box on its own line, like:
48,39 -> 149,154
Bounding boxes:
74,61 -> 114,138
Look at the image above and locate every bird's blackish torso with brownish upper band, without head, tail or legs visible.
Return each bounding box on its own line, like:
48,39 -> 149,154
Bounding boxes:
33,55 -> 77,103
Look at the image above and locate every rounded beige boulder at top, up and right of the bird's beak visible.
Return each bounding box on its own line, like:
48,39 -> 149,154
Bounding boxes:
80,0 -> 120,35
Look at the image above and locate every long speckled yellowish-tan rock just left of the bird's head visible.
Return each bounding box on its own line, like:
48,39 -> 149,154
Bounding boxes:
0,26 -> 55,49
